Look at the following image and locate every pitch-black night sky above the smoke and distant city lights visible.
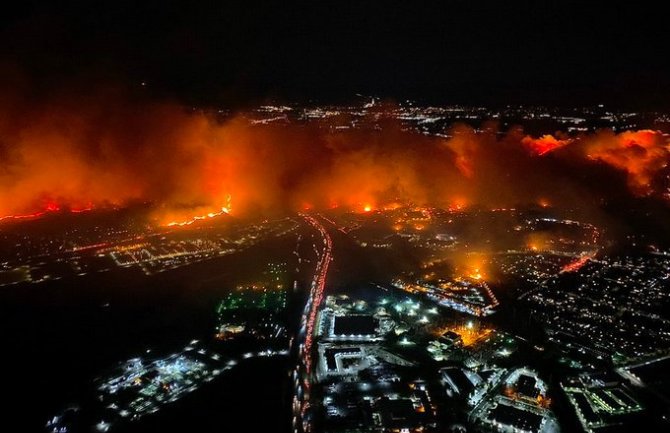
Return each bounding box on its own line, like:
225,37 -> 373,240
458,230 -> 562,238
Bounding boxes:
0,0 -> 670,109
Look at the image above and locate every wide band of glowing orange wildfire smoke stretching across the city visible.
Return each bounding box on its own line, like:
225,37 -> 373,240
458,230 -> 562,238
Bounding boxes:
0,89 -> 669,221
